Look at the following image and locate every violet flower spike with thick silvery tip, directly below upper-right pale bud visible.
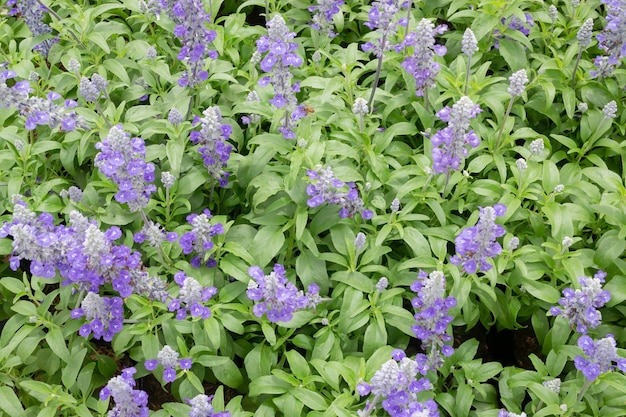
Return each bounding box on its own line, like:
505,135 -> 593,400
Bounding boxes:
431,96 -> 481,174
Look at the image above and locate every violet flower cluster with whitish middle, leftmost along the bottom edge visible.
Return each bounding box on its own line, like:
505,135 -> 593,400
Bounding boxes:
100,368 -> 150,417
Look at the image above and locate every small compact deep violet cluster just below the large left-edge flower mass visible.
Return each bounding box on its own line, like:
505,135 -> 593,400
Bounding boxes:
71,292 -> 124,342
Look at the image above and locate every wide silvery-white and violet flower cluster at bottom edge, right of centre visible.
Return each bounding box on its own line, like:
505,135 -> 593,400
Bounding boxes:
357,349 -> 439,417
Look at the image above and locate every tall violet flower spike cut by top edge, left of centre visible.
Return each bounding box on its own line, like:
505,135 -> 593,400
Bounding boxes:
148,0 -> 217,88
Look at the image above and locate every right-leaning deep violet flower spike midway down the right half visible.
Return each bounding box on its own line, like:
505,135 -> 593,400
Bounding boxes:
450,204 -> 506,274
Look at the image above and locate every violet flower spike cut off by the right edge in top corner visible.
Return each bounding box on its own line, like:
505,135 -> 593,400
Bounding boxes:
591,0 -> 626,77
